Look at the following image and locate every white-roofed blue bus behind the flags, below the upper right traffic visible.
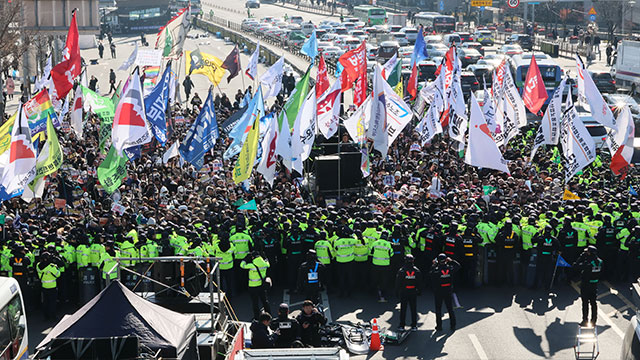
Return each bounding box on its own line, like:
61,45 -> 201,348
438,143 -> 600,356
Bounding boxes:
509,53 -> 562,104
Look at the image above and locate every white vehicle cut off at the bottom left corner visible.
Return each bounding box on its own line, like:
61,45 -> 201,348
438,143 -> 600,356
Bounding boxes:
0,277 -> 29,360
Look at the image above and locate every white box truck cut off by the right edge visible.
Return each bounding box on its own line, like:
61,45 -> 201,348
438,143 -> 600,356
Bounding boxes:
612,40 -> 640,95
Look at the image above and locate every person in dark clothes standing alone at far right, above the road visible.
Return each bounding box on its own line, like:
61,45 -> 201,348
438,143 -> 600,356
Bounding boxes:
573,245 -> 603,327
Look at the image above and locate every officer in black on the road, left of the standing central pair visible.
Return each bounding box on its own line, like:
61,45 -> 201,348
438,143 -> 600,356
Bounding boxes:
396,254 -> 423,331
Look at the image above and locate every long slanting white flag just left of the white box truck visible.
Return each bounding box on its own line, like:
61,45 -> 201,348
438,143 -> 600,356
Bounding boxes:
576,55 -> 618,132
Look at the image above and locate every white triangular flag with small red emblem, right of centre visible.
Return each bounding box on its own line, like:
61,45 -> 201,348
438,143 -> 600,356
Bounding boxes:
464,93 -> 509,174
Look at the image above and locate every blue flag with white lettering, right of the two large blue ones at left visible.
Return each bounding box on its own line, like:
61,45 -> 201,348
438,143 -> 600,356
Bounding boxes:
178,90 -> 220,170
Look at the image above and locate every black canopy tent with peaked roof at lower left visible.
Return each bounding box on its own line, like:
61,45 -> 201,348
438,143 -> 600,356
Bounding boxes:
36,281 -> 198,360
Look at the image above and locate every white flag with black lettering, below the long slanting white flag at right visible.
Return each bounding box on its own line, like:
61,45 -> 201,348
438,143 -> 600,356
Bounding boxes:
560,96 -> 596,182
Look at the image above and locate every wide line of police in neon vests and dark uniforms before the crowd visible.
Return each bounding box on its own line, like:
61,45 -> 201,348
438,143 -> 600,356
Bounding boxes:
5,202 -> 640,327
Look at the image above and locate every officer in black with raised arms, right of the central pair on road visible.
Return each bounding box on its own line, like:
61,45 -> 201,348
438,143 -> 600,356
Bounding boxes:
429,253 -> 460,331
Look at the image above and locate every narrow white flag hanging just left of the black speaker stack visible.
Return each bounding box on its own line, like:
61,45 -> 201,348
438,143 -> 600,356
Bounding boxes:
291,89 -> 318,174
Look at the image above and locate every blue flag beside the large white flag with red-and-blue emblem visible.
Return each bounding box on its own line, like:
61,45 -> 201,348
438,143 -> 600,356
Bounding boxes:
144,62 -> 171,146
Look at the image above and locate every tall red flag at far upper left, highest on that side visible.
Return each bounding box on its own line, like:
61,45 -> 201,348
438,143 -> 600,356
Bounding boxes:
51,11 -> 82,99
